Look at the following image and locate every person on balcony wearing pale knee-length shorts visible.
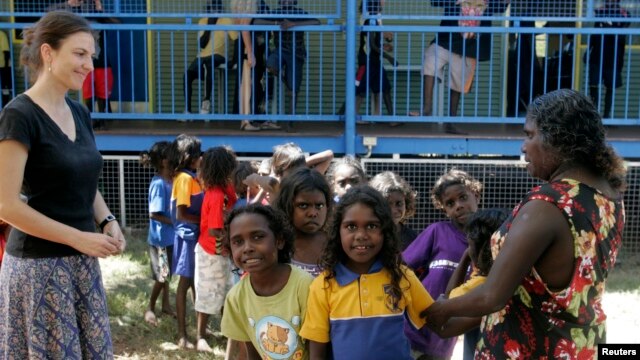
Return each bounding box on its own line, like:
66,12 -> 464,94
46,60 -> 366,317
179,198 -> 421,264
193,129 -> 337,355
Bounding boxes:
412,0 -> 509,134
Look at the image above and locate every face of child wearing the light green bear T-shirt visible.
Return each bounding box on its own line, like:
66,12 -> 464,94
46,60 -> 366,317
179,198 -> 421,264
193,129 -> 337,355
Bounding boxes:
229,213 -> 284,273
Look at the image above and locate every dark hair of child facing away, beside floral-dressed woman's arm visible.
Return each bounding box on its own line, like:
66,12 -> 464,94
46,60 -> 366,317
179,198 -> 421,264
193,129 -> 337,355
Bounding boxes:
464,208 -> 508,276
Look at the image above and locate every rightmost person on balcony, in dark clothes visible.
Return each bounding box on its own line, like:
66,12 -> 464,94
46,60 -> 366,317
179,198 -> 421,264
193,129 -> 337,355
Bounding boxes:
584,0 -> 629,118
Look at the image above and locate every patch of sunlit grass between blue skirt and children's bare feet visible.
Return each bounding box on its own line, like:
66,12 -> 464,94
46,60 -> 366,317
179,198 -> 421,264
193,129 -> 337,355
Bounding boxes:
100,233 -> 226,359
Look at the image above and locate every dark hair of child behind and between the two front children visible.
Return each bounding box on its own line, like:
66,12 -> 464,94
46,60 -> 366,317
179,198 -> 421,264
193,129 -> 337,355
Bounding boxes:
273,167 -> 333,230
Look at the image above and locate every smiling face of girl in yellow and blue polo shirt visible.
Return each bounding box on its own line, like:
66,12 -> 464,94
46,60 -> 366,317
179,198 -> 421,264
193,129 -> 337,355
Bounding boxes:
340,203 -> 384,274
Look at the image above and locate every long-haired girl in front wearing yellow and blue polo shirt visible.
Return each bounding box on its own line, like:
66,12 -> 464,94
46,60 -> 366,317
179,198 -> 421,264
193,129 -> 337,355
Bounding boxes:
300,186 -> 433,359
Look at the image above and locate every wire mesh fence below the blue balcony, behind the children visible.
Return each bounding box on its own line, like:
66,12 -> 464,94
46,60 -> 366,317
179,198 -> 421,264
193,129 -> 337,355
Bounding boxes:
100,156 -> 640,254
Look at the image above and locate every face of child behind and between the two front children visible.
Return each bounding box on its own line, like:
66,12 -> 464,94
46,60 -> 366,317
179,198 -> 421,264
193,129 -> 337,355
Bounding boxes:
292,190 -> 327,234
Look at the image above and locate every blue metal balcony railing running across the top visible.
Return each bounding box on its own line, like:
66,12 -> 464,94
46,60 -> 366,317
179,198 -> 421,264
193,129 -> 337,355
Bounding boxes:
0,0 -> 640,130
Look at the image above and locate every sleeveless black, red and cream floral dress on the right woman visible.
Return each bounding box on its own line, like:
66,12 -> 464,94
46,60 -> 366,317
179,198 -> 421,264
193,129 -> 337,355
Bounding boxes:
476,179 -> 624,359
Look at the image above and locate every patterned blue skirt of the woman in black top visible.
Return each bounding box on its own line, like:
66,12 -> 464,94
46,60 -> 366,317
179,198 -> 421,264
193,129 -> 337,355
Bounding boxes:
0,254 -> 113,359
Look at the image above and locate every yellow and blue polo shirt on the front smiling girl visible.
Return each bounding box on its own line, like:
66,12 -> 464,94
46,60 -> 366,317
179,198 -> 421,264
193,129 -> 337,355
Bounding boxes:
300,261 -> 433,359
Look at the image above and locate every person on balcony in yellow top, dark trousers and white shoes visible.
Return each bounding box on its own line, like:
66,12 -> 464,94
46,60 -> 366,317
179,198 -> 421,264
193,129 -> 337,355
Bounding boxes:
184,0 -> 238,114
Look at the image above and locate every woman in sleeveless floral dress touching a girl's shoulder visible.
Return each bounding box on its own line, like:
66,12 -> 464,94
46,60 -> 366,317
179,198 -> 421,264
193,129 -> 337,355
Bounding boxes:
424,89 -> 626,359
